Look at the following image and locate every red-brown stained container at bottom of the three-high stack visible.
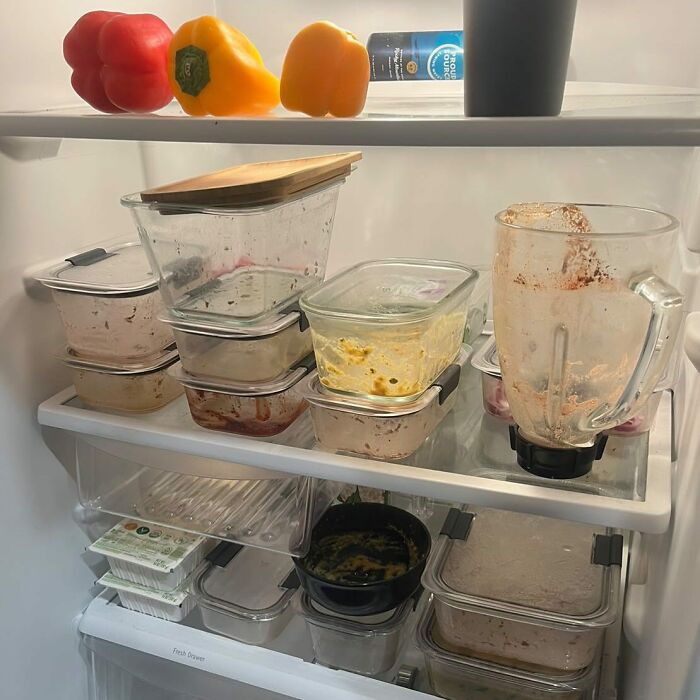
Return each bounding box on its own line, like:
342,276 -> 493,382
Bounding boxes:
169,355 -> 314,437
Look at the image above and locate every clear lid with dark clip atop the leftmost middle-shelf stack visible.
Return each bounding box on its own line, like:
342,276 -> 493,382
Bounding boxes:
36,241 -> 158,296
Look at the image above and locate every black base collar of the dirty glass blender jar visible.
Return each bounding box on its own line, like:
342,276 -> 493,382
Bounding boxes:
509,425 -> 608,479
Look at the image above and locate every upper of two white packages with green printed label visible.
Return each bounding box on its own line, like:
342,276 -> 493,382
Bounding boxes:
88,518 -> 212,591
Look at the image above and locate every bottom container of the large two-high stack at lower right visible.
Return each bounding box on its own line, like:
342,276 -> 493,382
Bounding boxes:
416,604 -> 600,700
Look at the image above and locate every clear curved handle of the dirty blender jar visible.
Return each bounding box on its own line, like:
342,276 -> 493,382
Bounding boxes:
588,273 -> 683,432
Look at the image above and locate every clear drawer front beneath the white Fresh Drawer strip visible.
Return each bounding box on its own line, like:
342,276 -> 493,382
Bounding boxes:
81,635 -> 288,700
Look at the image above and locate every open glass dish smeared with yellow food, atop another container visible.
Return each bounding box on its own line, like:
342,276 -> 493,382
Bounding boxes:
299,259 -> 478,405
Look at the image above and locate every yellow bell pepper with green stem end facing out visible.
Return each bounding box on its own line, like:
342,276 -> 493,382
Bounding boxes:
168,16 -> 279,117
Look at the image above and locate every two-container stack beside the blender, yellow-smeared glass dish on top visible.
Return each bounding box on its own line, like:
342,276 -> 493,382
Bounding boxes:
300,259 -> 478,459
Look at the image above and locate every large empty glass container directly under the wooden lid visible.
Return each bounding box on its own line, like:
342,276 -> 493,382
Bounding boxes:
121,178 -> 345,326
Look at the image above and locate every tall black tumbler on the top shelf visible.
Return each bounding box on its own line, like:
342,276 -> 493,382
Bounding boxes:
464,0 -> 576,117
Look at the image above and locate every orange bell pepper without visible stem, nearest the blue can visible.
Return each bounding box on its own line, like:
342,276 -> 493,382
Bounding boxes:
280,22 -> 369,117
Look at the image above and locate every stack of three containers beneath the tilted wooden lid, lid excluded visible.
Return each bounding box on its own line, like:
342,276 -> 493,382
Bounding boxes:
122,175 -> 345,436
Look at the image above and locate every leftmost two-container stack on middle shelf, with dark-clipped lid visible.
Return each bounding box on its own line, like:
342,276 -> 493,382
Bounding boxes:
36,241 -> 182,413
